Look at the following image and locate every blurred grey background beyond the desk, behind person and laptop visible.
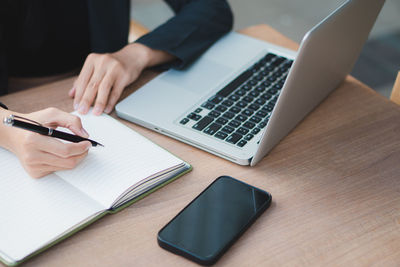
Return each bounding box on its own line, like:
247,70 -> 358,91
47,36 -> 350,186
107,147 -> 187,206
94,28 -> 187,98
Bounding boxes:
131,0 -> 400,97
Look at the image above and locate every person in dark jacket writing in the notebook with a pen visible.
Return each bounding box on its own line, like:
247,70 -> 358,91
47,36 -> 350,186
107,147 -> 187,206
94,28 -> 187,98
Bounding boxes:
0,0 -> 232,177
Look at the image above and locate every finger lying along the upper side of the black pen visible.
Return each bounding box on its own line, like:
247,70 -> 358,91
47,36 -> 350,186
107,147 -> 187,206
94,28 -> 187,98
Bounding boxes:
43,108 -> 89,138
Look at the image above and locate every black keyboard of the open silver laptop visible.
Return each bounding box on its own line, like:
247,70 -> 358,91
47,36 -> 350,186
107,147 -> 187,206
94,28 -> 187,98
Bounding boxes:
179,53 -> 293,147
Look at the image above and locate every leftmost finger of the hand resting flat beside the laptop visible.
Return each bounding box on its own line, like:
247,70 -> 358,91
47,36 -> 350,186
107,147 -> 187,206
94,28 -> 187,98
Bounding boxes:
74,54 -> 97,110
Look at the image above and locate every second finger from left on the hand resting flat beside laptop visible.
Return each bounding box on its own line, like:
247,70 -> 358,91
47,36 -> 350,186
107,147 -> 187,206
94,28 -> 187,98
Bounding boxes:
78,66 -> 105,114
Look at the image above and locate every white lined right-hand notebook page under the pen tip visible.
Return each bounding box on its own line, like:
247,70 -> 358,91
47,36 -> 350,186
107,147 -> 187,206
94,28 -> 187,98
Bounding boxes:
57,113 -> 182,207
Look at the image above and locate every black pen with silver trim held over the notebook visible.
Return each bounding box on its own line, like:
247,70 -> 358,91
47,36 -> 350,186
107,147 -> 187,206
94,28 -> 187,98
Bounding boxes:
3,115 -> 104,147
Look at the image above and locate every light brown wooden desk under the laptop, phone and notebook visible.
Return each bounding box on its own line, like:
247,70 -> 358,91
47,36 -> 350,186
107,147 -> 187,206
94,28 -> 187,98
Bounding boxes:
0,25 -> 400,266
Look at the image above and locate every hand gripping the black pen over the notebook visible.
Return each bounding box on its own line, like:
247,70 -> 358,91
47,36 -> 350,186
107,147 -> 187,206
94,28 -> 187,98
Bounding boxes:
9,108 -> 91,178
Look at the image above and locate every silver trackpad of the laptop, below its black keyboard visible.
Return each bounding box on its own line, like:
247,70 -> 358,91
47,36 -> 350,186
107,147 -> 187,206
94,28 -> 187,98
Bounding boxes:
161,58 -> 232,95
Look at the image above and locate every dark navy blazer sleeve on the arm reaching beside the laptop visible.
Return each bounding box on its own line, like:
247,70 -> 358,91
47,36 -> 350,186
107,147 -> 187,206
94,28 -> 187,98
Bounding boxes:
136,0 -> 233,69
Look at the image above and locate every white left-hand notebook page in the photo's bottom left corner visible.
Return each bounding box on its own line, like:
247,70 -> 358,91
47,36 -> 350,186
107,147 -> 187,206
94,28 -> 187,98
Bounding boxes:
0,148 -> 104,260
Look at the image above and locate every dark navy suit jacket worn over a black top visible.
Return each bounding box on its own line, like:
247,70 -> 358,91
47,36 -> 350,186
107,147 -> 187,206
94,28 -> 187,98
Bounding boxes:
0,0 -> 233,95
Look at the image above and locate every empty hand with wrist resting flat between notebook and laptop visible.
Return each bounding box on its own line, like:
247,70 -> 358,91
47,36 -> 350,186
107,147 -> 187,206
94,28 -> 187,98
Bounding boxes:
69,43 -> 174,115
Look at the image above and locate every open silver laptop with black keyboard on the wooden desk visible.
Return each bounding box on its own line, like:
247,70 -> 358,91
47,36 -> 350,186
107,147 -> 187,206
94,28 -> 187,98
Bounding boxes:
116,0 -> 384,166
